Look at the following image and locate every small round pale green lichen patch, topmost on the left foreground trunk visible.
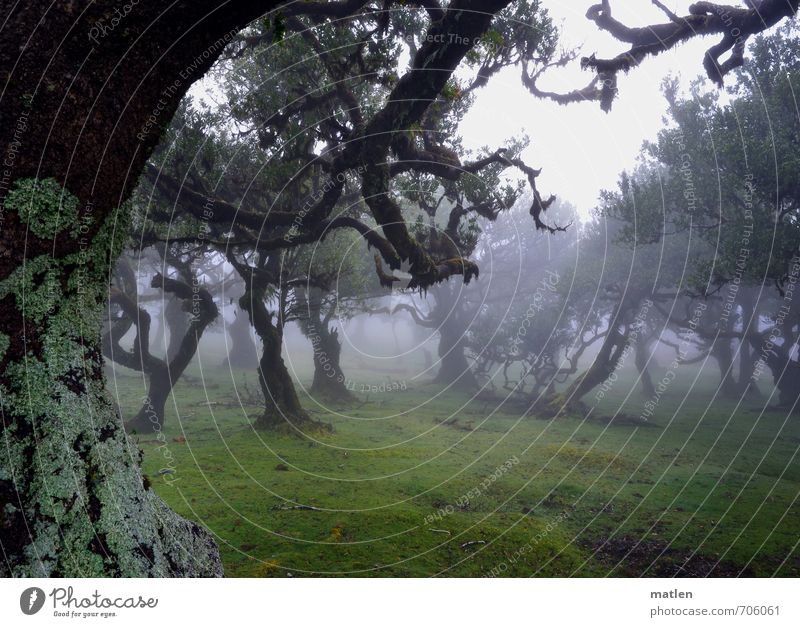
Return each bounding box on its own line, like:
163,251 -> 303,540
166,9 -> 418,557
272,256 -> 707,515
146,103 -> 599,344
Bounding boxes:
5,178 -> 80,239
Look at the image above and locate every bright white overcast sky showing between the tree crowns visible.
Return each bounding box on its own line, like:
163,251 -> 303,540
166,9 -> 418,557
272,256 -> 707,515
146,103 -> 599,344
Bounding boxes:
461,0 -> 713,216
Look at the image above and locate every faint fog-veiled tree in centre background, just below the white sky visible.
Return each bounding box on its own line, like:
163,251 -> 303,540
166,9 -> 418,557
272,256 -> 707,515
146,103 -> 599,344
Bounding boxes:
466,200 -> 581,406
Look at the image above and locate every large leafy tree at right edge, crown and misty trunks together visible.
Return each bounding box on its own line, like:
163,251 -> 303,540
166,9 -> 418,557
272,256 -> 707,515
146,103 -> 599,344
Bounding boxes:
606,27 -> 800,408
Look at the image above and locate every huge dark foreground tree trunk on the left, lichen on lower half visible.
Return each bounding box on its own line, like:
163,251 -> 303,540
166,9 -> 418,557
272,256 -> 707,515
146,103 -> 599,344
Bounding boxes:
0,0 -> 288,577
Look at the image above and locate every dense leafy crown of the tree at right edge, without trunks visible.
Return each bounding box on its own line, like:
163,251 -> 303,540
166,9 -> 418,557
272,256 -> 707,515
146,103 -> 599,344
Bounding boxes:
602,25 -> 800,290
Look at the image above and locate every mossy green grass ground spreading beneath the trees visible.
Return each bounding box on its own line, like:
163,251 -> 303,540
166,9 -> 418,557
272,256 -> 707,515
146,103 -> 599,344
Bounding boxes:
111,369 -> 800,577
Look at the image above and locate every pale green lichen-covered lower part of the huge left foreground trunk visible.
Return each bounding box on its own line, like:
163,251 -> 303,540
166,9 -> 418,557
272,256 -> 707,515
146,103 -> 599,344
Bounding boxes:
0,180 -> 222,577
